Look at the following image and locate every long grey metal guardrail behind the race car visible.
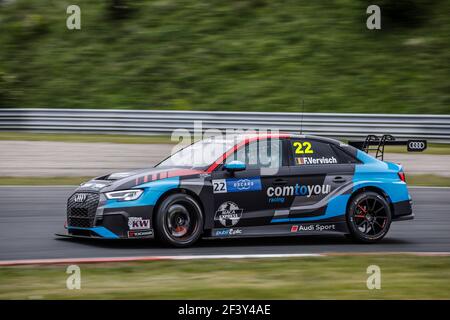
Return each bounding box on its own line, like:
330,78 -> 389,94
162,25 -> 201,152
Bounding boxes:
0,109 -> 450,142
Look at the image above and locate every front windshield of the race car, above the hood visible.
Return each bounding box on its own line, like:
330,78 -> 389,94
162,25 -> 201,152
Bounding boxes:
157,137 -> 237,168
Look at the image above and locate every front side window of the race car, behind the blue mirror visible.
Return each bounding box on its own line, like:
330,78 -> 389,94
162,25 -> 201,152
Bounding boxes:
226,139 -> 282,169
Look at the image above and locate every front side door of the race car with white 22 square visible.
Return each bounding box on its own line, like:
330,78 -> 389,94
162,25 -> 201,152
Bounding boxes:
212,139 -> 290,235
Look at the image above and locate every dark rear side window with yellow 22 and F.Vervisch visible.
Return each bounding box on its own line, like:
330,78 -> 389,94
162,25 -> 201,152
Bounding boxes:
291,139 -> 341,166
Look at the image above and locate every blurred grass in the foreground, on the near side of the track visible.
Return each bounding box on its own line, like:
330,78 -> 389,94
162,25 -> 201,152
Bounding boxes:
0,255 -> 450,299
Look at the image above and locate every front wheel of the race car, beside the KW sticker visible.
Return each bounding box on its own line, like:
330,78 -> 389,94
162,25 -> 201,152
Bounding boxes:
155,193 -> 204,247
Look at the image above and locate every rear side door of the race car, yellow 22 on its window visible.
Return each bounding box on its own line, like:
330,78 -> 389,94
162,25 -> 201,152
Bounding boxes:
273,138 -> 357,222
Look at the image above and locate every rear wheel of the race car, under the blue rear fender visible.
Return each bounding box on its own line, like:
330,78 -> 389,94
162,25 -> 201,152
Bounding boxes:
346,191 -> 392,243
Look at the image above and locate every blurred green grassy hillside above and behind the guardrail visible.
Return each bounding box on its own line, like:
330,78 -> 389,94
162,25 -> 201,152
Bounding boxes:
0,0 -> 450,114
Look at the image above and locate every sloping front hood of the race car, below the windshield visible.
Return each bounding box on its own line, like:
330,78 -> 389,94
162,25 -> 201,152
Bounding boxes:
76,167 -> 203,192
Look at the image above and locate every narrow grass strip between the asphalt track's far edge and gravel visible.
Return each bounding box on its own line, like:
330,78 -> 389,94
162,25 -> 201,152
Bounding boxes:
0,174 -> 450,187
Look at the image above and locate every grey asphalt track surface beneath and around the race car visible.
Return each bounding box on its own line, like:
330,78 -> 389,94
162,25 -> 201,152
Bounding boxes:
0,186 -> 450,260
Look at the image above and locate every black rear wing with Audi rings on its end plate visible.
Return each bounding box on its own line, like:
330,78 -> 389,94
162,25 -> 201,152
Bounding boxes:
348,134 -> 427,160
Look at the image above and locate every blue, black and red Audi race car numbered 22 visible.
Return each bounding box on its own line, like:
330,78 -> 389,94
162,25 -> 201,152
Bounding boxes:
60,133 -> 426,247
